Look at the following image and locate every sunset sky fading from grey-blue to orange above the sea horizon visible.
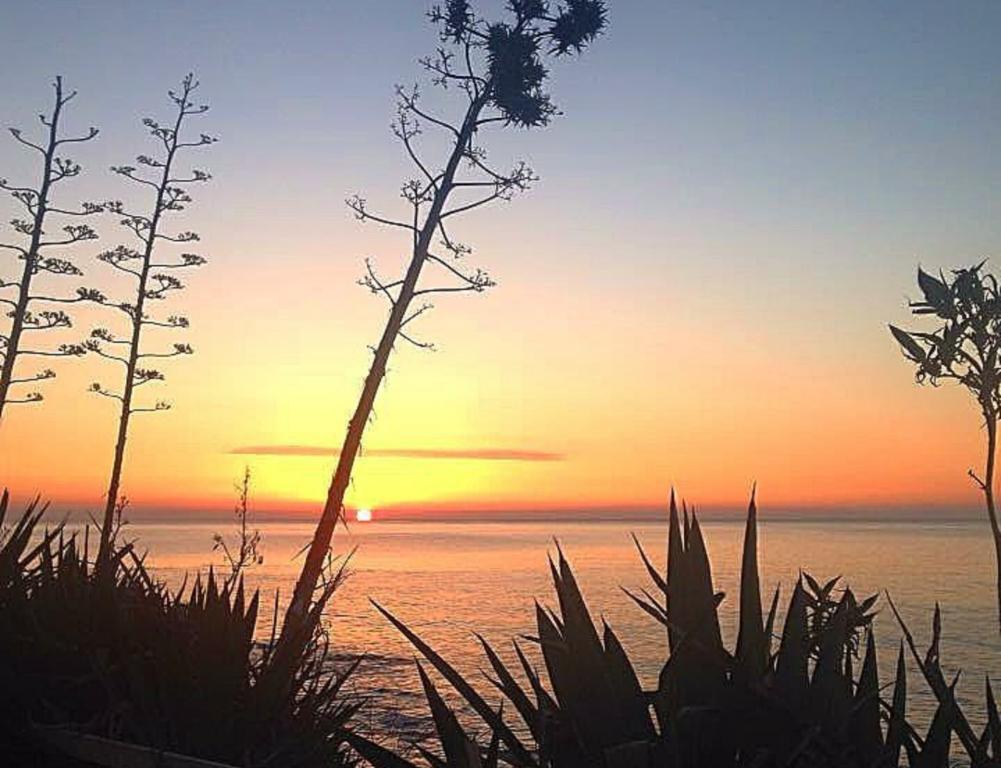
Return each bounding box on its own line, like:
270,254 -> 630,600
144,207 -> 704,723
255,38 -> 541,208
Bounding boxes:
0,0 -> 1001,511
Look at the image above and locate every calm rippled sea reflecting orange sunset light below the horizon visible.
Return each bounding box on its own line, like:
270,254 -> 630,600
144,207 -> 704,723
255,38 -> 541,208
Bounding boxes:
128,520 -> 1001,740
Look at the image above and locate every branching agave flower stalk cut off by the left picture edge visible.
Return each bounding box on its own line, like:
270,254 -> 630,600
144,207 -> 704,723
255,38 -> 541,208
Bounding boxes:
0,77 -> 103,418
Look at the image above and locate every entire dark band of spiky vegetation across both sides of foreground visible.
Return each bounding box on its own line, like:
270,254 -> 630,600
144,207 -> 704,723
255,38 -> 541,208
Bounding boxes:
0,488 -> 1001,768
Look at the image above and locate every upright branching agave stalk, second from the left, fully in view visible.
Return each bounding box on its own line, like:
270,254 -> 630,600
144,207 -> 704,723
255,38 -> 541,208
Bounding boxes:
86,74 -> 216,569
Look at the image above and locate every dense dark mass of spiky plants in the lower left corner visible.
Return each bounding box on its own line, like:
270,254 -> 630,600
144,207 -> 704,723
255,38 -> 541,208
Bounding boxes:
0,495 -> 358,767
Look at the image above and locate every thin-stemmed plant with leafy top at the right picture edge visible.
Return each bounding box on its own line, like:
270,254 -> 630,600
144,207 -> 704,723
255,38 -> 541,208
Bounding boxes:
890,261 -> 1001,629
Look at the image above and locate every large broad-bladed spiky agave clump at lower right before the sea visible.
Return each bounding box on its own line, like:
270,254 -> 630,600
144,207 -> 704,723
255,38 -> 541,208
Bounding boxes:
360,499 -> 1001,768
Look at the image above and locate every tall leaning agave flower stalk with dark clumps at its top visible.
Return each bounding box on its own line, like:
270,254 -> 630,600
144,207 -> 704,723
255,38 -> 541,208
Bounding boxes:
280,0 -> 606,660
